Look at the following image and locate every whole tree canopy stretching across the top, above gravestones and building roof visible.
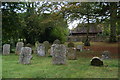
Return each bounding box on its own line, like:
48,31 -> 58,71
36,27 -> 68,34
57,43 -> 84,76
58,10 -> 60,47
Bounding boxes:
2,1 -> 120,44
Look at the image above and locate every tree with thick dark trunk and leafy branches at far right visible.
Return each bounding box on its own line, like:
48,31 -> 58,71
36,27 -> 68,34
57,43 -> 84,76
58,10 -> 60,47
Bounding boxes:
93,2 -> 120,42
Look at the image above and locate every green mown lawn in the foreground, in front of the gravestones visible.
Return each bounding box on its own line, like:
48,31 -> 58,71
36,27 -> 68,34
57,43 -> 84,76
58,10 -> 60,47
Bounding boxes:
2,54 -> 118,78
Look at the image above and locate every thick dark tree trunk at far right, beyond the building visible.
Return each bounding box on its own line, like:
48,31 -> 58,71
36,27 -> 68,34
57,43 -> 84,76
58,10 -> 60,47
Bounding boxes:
109,2 -> 117,42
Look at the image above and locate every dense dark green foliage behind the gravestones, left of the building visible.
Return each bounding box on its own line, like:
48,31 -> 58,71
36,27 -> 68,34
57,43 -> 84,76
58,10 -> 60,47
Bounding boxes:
2,2 -> 68,44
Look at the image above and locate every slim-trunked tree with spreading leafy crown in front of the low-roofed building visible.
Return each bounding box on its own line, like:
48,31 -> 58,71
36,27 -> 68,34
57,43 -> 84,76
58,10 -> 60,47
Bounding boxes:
60,2 -> 101,46
